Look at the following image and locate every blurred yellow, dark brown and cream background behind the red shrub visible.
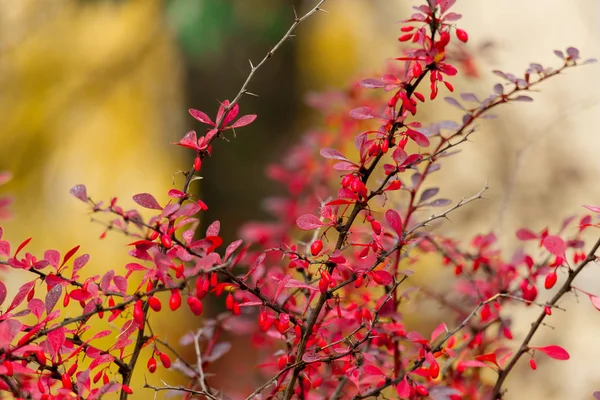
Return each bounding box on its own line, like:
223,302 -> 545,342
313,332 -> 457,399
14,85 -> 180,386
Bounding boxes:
0,0 -> 600,399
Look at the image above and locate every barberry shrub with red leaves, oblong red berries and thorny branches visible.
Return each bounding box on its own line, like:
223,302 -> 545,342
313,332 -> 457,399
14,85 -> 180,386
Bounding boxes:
0,0 -> 600,400
